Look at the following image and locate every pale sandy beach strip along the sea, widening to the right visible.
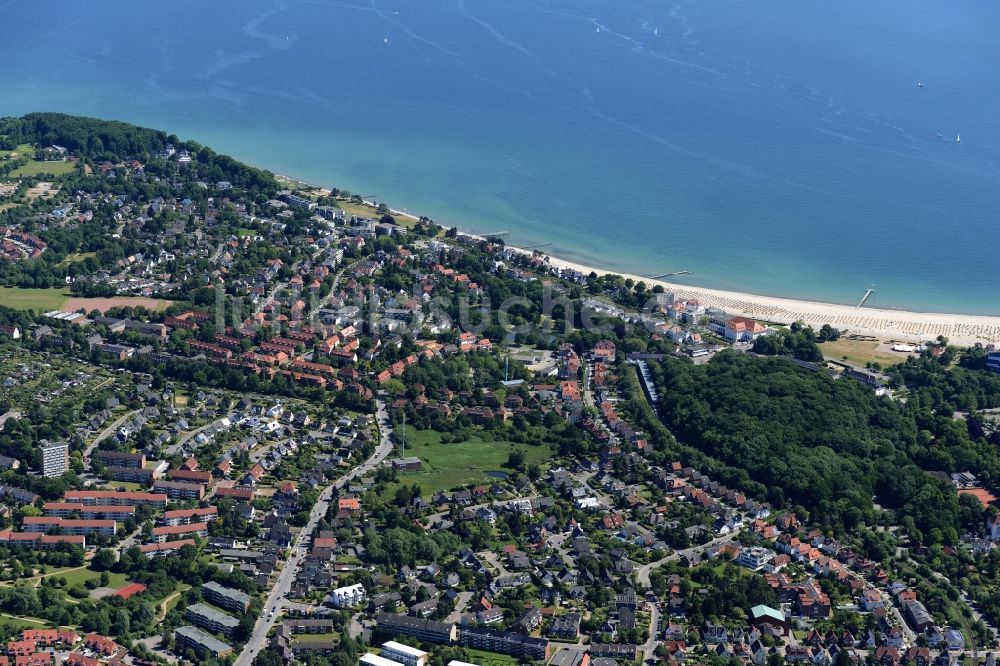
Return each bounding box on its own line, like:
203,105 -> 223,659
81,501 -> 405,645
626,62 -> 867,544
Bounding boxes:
275,174 -> 1000,346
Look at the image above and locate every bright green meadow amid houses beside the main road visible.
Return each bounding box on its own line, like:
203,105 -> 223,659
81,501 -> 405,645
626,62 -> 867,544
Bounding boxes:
390,428 -> 552,493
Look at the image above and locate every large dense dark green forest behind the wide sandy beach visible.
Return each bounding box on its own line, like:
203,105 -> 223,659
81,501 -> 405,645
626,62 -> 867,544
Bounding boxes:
650,352 -> 1000,543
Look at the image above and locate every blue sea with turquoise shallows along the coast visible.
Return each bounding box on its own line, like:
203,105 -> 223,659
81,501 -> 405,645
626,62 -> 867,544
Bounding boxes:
0,0 -> 1000,314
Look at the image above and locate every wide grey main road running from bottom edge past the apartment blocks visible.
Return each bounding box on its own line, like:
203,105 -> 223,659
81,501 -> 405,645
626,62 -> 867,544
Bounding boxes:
235,398 -> 393,666
